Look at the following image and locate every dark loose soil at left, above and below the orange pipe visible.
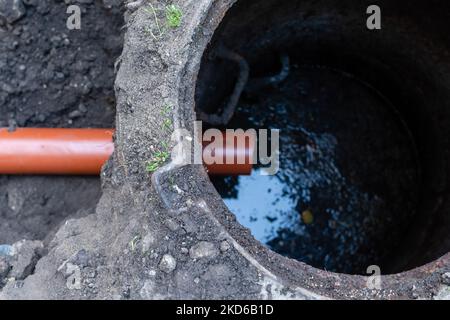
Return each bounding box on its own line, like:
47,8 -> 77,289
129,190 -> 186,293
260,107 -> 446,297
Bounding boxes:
0,0 -> 124,243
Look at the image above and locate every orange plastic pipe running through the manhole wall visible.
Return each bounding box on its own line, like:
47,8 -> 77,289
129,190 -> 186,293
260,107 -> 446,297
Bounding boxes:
0,128 -> 254,175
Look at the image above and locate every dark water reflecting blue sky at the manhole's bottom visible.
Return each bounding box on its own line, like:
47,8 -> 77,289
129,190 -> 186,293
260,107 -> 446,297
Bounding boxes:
211,67 -> 419,274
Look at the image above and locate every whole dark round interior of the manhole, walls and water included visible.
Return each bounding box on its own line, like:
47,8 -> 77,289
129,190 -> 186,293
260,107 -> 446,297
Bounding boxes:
196,0 -> 450,274
